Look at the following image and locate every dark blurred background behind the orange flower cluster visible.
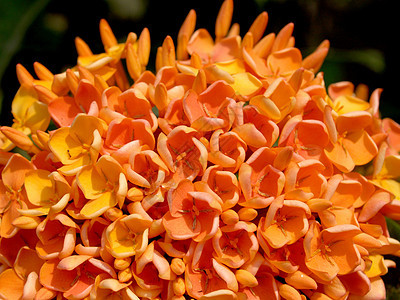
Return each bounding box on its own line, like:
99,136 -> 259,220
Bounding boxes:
0,0 -> 400,299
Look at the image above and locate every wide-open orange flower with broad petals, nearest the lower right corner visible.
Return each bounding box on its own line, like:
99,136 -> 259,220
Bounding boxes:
304,222 -> 361,281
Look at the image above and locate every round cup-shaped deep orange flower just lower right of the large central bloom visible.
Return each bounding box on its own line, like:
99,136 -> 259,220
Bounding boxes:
212,221 -> 258,268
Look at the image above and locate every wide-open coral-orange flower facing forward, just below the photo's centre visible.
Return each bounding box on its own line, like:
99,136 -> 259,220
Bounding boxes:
163,180 -> 221,242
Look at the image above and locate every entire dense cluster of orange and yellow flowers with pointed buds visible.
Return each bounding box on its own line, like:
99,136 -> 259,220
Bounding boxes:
0,0 -> 400,300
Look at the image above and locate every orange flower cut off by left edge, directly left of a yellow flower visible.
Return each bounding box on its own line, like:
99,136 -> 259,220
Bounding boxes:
0,154 -> 33,238
